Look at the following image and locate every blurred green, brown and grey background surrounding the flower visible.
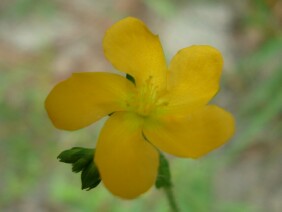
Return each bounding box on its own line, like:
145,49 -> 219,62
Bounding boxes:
0,0 -> 282,212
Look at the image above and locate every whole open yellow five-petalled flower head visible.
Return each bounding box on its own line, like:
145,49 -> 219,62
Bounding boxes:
45,17 -> 234,199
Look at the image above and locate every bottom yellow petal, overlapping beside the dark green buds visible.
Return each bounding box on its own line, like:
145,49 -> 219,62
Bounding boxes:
95,112 -> 159,199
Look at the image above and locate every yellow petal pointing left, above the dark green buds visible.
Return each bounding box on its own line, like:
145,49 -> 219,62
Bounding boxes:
45,72 -> 135,130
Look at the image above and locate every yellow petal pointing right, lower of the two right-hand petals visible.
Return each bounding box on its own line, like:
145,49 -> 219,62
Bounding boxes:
144,106 -> 235,158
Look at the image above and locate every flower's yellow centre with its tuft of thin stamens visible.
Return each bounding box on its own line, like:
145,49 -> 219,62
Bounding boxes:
128,77 -> 167,117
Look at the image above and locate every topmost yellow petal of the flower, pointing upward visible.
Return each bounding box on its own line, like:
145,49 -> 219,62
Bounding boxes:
103,17 -> 167,88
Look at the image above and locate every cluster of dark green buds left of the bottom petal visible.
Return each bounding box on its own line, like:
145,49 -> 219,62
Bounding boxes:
58,147 -> 101,191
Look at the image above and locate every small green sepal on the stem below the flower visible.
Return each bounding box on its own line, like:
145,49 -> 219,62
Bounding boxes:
155,153 -> 172,188
